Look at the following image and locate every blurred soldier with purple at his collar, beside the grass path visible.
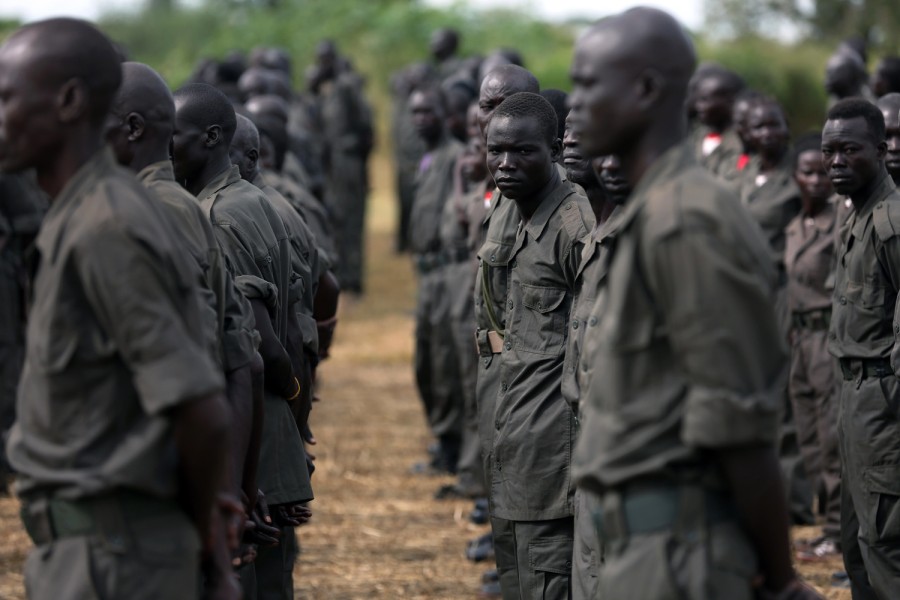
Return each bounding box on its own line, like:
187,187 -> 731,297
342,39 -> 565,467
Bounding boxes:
409,87 -> 463,473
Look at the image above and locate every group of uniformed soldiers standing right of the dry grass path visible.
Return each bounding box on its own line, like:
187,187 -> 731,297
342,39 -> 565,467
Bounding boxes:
394,10 -> 900,598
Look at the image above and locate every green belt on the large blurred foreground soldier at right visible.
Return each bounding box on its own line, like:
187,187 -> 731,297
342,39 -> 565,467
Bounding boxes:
593,484 -> 736,544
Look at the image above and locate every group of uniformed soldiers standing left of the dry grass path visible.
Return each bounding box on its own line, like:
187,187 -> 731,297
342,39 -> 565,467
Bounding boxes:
0,19 -> 371,599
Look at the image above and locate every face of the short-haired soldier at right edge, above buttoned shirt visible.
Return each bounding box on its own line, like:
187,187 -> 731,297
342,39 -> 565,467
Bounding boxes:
822,117 -> 886,197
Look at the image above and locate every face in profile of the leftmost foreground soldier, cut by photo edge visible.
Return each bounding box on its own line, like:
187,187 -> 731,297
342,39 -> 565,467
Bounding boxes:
0,34 -> 61,172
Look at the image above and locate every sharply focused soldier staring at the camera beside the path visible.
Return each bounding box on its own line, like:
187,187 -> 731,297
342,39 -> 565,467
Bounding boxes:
476,93 -> 594,599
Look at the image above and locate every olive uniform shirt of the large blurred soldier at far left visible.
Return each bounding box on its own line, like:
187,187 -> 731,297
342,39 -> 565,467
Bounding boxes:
8,149 -> 224,498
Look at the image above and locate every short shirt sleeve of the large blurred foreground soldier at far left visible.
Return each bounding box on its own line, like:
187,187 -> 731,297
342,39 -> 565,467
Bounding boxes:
76,227 -> 224,415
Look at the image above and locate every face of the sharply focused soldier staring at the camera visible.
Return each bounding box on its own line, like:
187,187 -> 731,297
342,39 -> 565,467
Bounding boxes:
487,116 -> 560,200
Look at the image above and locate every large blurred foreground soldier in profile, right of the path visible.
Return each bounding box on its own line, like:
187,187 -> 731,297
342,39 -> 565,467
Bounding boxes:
570,8 -> 818,600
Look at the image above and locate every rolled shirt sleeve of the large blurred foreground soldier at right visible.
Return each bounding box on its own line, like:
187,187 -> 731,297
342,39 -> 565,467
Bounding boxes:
645,226 -> 787,448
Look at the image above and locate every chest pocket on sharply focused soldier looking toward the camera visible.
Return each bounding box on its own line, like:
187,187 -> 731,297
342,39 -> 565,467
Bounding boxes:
513,283 -> 571,355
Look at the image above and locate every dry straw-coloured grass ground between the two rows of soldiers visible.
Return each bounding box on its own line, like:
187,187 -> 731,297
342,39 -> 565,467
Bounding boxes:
0,152 -> 850,600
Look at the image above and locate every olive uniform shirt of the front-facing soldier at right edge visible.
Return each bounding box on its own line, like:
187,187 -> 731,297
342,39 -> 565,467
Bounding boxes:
828,172 -> 900,364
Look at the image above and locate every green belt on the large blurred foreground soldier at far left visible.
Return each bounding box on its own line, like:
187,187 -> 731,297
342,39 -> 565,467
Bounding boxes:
21,491 -> 180,546
